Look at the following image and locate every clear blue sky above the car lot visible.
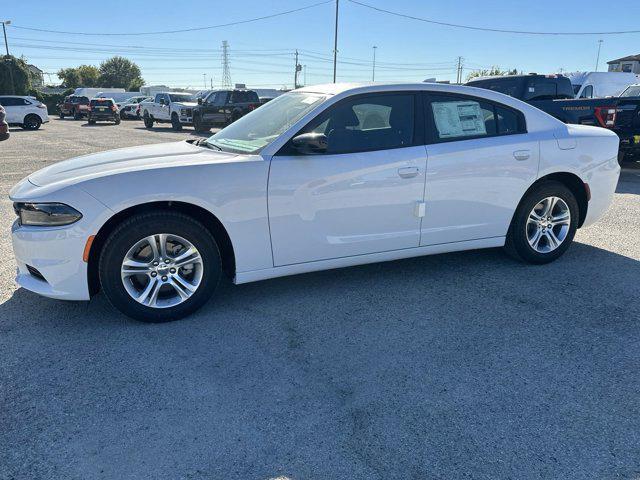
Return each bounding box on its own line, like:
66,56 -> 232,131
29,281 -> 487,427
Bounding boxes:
5,0 -> 640,88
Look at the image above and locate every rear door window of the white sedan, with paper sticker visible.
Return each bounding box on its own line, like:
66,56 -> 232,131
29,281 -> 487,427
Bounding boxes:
428,95 -> 526,142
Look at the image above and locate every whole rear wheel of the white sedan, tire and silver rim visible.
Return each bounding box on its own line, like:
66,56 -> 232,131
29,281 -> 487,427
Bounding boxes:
505,181 -> 579,264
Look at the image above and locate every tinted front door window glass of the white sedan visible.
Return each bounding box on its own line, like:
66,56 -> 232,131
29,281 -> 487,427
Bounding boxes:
300,94 -> 415,155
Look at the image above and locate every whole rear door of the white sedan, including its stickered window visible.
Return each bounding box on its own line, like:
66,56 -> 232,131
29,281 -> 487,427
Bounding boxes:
420,94 -> 539,245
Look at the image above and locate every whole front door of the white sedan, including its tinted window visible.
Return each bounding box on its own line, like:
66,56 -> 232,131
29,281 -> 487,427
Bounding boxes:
268,92 -> 426,266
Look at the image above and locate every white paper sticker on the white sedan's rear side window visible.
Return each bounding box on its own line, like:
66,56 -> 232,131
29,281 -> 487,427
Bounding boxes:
431,101 -> 487,138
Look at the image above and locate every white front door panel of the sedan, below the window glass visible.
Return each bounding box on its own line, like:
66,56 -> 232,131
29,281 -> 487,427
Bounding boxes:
269,146 -> 427,266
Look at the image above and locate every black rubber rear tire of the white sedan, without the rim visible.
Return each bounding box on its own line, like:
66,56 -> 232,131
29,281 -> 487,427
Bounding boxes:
505,181 -> 580,264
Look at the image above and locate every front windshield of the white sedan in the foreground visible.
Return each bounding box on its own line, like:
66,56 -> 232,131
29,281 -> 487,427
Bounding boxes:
207,92 -> 327,153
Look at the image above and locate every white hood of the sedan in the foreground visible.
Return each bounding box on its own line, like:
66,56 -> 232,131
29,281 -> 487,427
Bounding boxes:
29,141 -> 245,187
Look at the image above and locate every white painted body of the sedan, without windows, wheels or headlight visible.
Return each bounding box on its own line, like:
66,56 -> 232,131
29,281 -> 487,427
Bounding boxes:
10,84 -> 620,300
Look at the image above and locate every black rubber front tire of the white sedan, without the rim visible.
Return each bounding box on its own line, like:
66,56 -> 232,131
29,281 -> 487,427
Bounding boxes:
98,211 -> 222,323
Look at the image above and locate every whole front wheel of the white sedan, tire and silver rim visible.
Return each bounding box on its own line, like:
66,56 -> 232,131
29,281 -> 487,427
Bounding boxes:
99,211 -> 222,322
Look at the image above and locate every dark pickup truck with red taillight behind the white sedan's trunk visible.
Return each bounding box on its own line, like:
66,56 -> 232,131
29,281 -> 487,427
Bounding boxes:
467,74 -> 640,161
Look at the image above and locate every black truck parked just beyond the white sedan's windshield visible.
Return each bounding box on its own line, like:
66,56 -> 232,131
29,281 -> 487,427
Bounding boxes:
193,89 -> 261,132
